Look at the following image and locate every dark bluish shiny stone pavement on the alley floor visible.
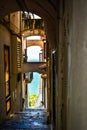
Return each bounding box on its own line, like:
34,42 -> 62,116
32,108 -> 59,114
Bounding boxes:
0,109 -> 51,130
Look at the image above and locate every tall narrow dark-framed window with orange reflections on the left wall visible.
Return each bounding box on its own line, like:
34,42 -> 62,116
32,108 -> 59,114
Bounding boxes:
4,46 -> 11,113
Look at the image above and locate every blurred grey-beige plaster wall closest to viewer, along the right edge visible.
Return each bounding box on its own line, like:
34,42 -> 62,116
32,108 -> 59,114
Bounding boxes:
67,0 -> 87,130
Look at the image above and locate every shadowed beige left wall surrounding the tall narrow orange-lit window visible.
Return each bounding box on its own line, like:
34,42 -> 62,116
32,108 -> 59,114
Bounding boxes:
0,25 -> 21,123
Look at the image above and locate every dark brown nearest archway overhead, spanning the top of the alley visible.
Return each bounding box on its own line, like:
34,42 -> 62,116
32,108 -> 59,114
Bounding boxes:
0,0 -> 57,48
